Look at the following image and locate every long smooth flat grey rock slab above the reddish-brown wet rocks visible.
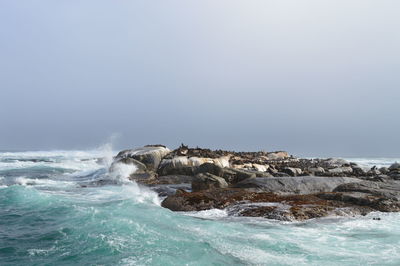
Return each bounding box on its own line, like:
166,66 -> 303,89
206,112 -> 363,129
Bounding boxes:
234,176 -> 361,194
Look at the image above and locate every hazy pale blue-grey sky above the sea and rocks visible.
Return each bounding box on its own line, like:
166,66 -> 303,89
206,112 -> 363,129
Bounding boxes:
0,0 -> 400,157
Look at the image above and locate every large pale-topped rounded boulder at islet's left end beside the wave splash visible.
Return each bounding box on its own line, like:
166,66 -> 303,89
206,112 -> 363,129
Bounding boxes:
115,145 -> 171,170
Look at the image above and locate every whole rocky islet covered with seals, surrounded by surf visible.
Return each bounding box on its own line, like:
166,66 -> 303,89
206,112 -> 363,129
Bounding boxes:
110,144 -> 400,221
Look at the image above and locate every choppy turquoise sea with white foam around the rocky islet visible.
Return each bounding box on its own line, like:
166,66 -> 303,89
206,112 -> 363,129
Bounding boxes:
0,151 -> 400,265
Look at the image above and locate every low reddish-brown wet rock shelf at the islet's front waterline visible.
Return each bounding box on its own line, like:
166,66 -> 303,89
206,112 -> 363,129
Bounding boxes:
161,189 -> 373,221
